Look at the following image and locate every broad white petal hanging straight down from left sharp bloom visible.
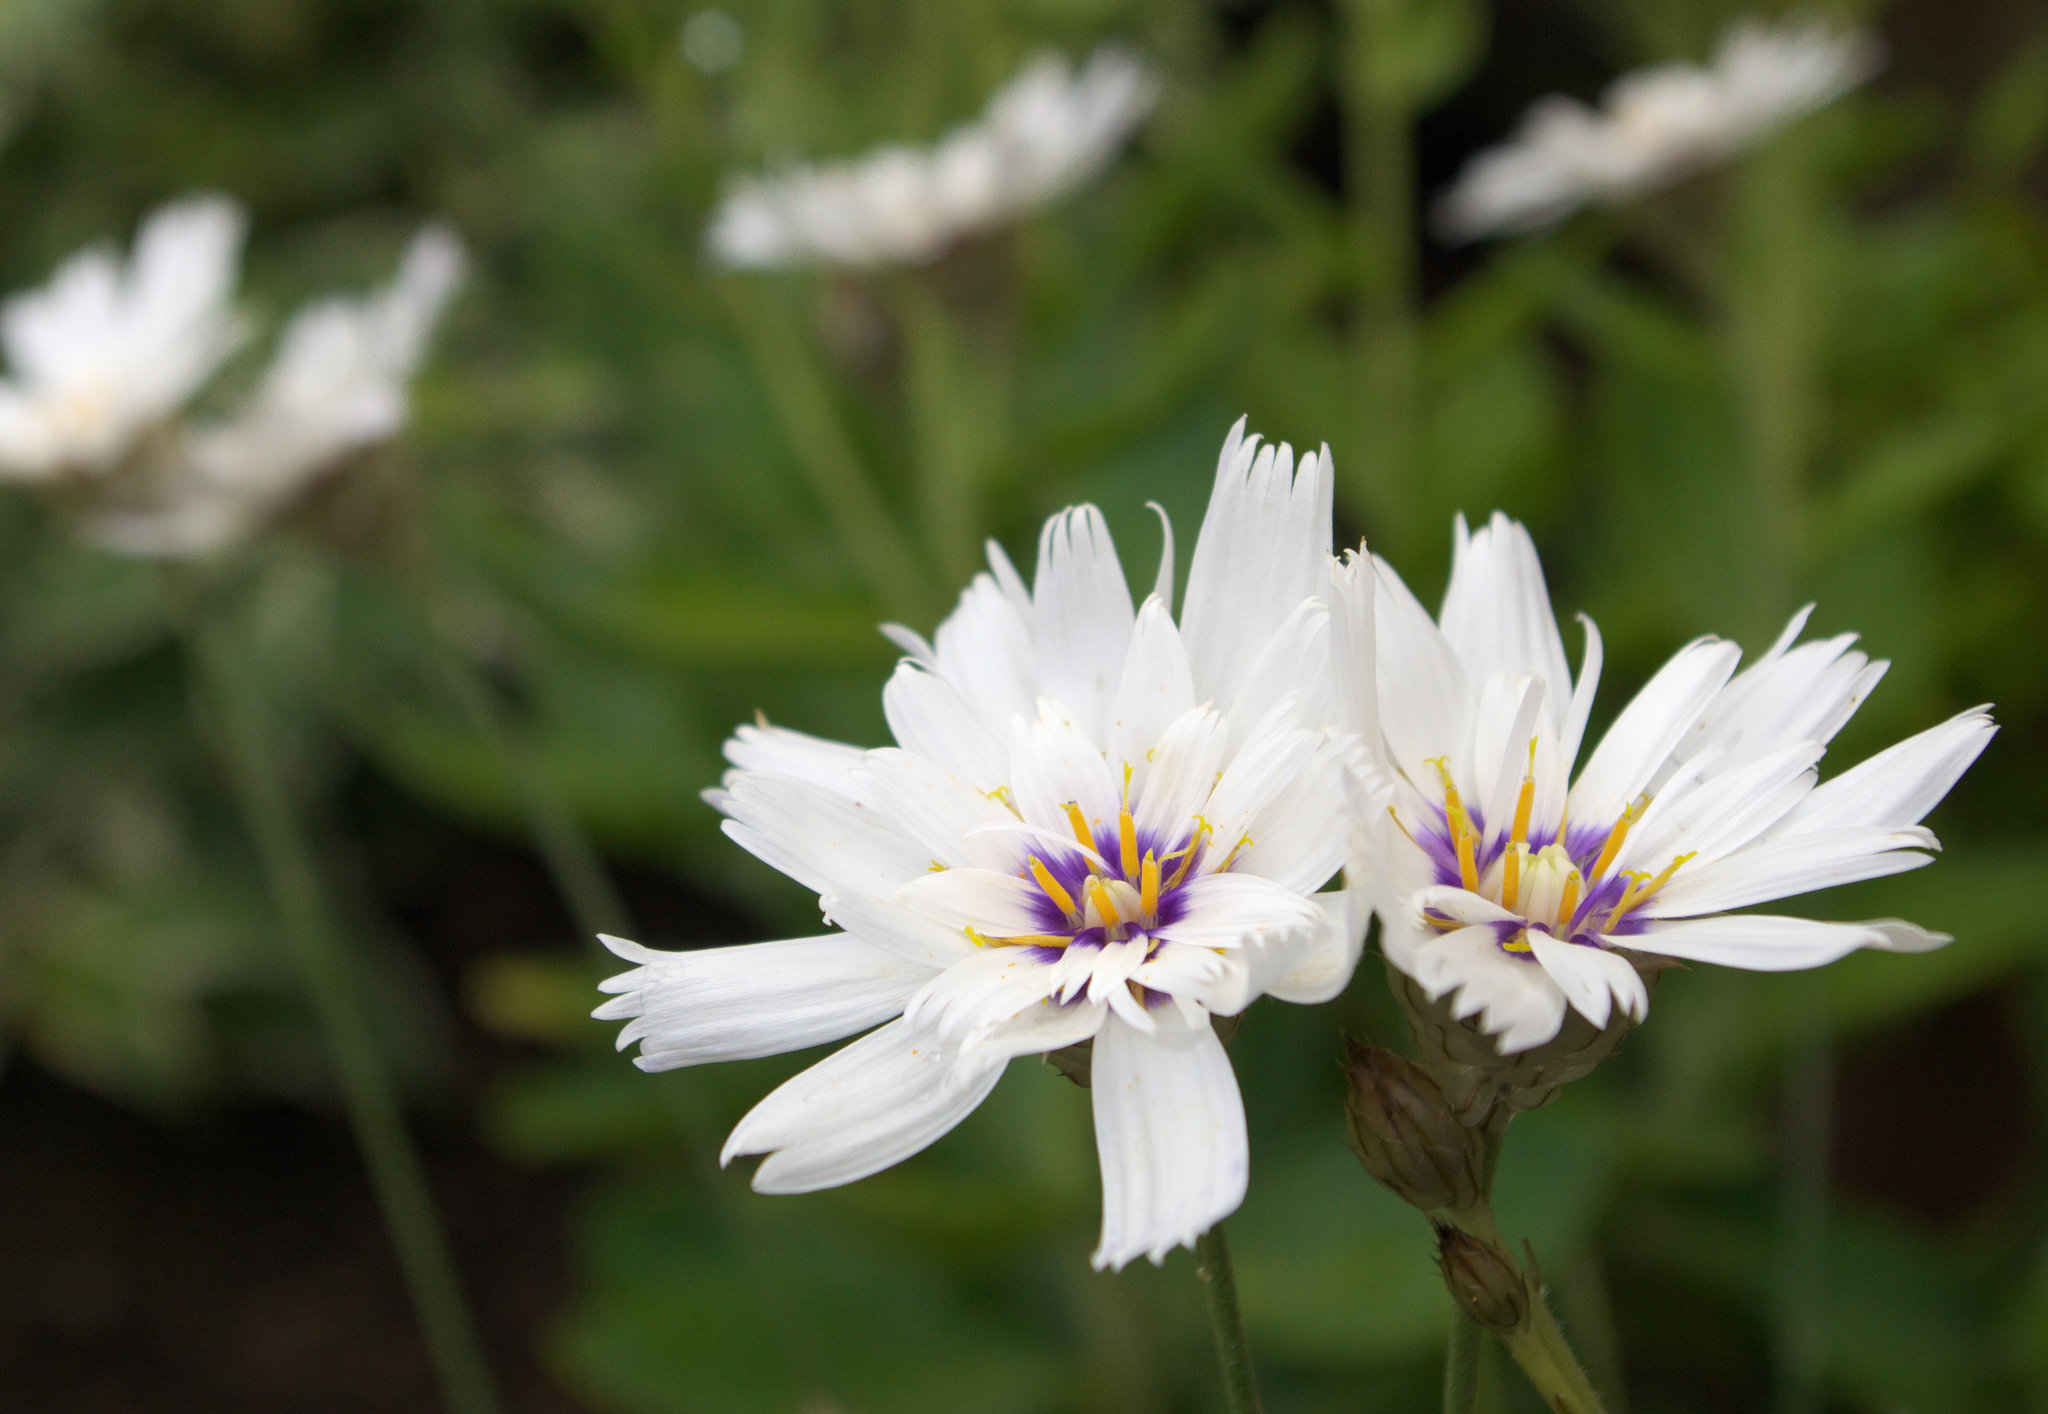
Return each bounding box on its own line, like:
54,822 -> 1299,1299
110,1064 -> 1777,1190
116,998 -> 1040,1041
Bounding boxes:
1090,1008 -> 1251,1269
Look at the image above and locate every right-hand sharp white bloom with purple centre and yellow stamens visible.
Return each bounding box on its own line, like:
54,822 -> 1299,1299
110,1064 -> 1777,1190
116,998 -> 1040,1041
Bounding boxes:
1339,514 -> 1995,1053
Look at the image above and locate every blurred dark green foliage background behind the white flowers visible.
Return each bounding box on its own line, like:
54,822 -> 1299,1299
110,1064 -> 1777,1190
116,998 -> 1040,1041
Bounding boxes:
0,0 -> 2048,1414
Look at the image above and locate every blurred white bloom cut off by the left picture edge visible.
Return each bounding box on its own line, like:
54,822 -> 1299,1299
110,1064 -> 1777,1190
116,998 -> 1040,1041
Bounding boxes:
0,197 -> 246,482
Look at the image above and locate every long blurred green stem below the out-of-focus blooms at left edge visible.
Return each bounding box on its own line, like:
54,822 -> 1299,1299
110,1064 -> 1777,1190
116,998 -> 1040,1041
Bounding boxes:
193,623 -> 500,1414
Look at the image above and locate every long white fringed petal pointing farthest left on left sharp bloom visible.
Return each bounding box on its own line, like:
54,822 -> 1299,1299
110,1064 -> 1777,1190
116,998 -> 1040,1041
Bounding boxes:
592,932 -> 932,1070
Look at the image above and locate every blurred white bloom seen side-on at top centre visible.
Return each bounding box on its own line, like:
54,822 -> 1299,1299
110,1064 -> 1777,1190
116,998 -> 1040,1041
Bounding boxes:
705,45 -> 1159,268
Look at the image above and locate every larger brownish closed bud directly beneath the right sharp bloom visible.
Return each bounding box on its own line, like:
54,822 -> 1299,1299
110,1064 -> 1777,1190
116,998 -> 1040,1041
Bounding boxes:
1346,1041 -> 1485,1213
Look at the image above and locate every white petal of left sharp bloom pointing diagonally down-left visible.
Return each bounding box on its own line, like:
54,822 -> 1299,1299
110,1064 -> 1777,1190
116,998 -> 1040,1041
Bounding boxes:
719,1021 -> 1004,1193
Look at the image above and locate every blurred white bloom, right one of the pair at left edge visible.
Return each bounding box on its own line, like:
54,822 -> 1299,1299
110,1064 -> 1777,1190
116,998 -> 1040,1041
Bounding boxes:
88,225 -> 463,557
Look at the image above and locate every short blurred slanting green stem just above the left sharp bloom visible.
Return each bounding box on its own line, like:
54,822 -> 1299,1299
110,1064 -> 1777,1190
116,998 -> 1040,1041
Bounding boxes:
719,277 -> 928,617
